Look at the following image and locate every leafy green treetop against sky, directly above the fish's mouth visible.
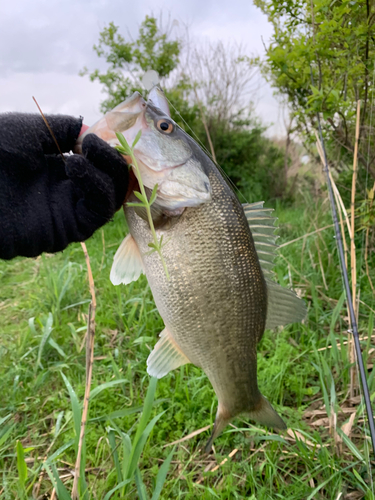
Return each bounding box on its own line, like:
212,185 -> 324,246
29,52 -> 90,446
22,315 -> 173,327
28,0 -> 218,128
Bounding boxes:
81,16 -> 181,113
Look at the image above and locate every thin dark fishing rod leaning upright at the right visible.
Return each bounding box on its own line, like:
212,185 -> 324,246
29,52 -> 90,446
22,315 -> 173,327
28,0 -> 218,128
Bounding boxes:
310,65 -> 375,455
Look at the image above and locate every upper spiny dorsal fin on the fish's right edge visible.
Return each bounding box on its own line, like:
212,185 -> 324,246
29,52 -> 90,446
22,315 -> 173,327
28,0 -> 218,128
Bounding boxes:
242,201 -> 278,279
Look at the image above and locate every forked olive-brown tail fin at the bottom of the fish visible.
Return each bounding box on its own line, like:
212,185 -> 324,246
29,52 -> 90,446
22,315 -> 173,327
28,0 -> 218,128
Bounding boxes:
204,395 -> 287,453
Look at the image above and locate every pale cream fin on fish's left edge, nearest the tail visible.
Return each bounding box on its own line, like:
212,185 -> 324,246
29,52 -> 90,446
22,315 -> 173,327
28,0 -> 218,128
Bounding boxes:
147,328 -> 190,378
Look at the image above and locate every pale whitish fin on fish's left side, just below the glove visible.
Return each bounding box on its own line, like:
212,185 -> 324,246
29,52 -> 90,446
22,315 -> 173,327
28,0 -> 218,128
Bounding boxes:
110,234 -> 144,285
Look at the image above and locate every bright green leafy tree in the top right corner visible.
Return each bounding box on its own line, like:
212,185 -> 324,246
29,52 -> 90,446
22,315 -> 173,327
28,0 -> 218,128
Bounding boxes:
255,0 -> 375,179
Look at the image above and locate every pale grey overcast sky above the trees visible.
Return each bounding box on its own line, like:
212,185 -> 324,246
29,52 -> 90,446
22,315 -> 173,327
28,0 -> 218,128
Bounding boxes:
0,0 -> 284,134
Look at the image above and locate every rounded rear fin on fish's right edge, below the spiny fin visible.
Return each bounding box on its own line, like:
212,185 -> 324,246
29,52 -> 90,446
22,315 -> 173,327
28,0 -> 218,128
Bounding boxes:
266,279 -> 306,328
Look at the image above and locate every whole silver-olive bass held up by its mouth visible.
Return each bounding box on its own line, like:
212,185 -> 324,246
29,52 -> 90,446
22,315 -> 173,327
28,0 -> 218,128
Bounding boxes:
81,89 -> 306,453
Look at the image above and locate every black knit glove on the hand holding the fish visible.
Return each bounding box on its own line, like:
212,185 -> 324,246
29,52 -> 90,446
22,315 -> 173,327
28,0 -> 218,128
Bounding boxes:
0,113 -> 128,259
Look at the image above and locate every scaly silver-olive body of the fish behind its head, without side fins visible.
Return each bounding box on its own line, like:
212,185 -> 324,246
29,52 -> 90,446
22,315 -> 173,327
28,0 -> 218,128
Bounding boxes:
125,132 -> 285,447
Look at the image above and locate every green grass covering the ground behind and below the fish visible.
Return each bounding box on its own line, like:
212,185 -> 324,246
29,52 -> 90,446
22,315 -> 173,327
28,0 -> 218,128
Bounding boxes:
0,201 -> 375,500
